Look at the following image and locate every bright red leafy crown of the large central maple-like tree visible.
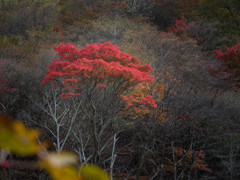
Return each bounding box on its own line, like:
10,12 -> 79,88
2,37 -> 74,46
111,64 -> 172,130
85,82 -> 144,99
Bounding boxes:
41,42 -> 156,108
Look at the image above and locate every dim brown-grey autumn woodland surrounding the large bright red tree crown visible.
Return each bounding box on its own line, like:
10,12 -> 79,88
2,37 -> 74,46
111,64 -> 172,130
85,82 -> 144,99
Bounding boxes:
0,0 -> 240,180
